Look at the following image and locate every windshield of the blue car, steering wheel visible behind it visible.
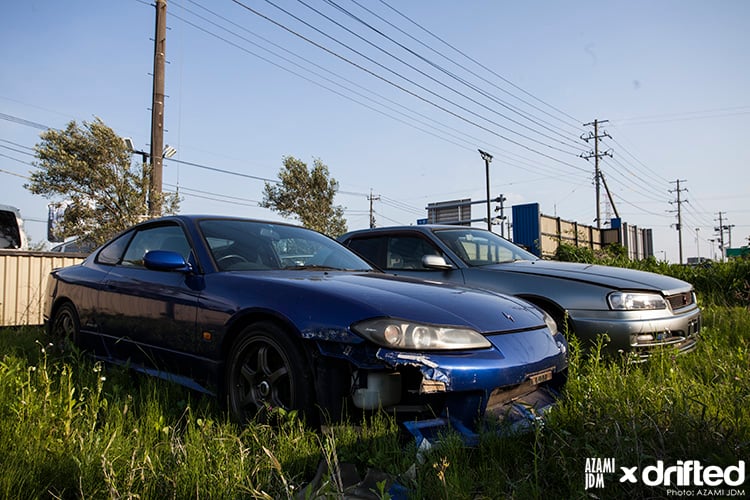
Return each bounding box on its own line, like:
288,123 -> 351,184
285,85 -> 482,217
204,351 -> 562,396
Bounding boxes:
200,219 -> 372,271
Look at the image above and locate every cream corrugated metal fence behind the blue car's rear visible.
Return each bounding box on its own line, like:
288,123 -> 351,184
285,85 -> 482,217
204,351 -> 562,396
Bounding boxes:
0,250 -> 85,326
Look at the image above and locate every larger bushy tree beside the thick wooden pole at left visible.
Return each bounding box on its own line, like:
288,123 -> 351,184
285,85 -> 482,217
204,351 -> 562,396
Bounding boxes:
24,118 -> 179,245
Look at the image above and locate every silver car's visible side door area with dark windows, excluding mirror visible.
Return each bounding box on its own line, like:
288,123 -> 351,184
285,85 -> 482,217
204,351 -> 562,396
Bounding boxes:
347,232 -> 464,283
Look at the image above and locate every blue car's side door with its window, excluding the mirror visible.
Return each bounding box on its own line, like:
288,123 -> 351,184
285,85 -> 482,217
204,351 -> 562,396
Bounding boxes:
99,222 -> 202,372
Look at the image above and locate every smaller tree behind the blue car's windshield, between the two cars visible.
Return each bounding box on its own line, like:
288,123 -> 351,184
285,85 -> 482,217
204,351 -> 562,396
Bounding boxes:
260,156 -> 347,237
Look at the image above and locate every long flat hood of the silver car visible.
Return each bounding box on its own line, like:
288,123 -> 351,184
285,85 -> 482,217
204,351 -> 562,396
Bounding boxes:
490,260 -> 692,295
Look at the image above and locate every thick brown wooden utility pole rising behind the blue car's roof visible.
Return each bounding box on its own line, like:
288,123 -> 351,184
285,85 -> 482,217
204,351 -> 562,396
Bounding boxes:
148,0 -> 167,217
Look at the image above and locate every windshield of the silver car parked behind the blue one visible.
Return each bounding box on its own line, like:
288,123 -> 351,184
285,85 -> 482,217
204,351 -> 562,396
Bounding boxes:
435,228 -> 538,266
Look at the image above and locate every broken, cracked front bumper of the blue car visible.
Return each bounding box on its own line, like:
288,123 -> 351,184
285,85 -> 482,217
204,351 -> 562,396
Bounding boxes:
314,328 -> 567,428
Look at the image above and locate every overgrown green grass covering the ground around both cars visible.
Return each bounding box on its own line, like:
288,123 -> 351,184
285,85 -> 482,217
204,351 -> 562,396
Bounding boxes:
0,307 -> 750,499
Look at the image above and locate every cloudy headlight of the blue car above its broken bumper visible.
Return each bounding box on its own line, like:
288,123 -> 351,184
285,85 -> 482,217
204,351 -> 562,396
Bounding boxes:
352,318 -> 490,351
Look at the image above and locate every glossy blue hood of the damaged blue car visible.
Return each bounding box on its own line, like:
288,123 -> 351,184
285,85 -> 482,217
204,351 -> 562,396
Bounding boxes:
217,271 -> 545,333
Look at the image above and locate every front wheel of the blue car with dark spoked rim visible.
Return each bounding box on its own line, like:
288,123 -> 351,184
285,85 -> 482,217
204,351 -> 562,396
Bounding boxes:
226,322 -> 314,424
